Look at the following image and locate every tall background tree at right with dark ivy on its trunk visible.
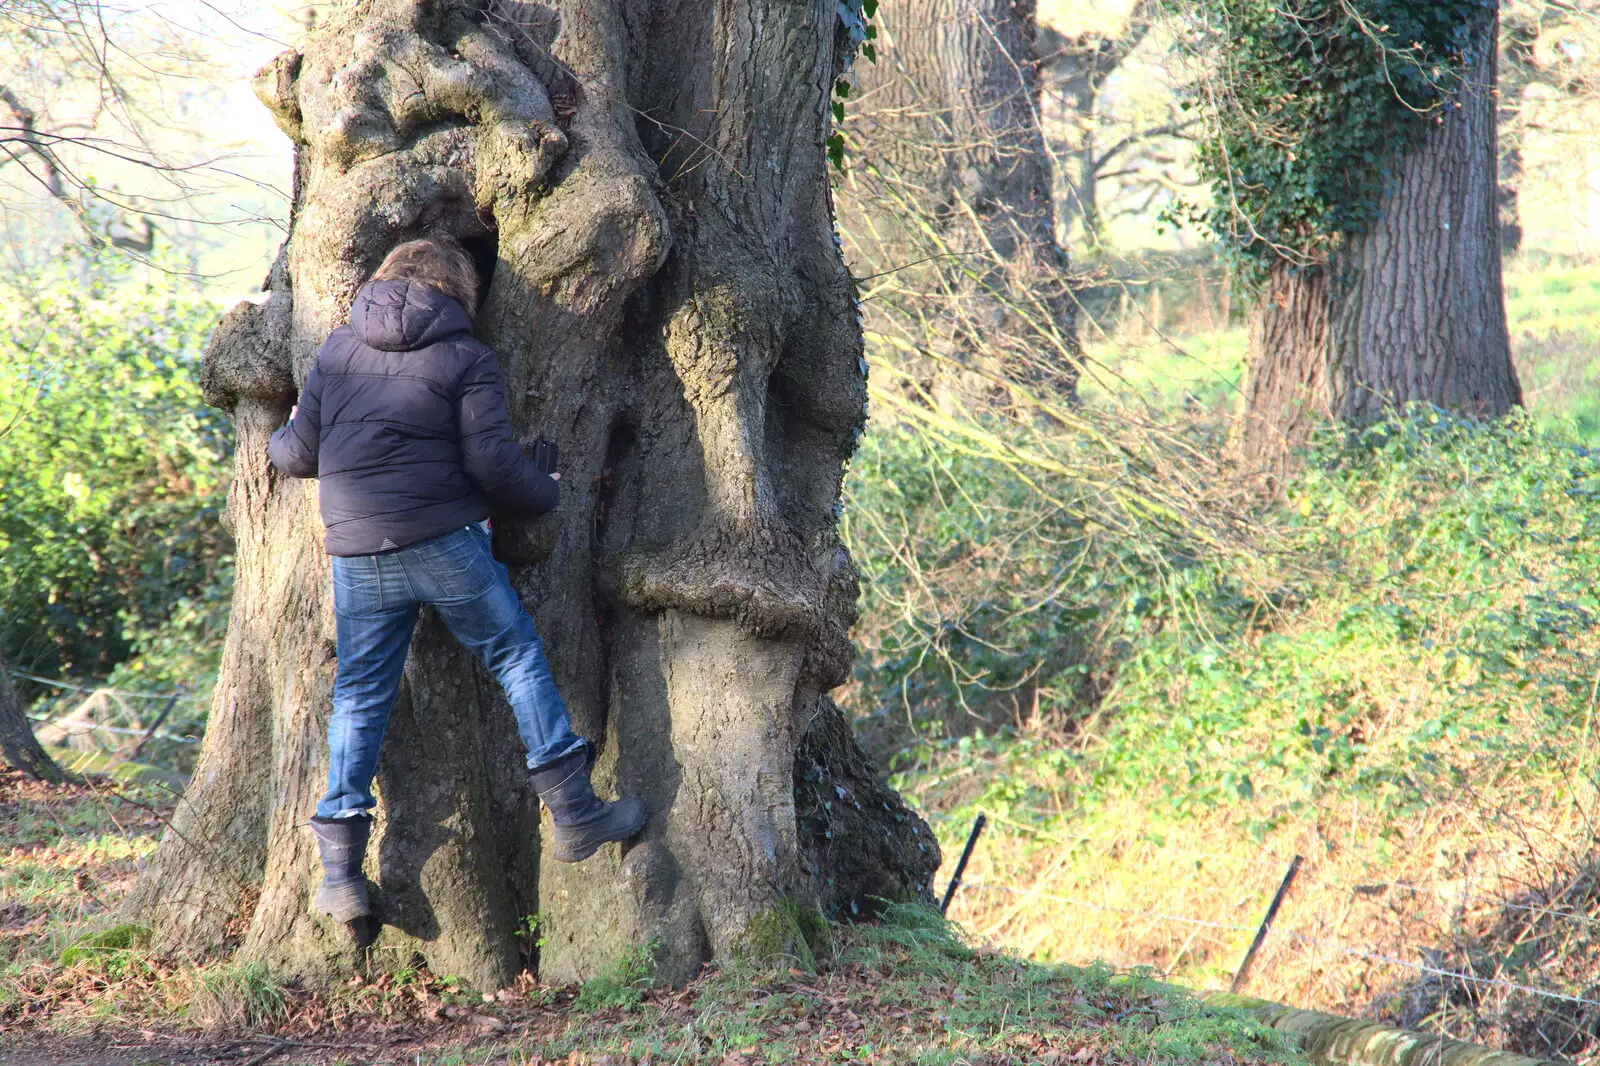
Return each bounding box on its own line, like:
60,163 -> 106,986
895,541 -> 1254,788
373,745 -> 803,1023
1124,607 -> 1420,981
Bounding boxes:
1203,0 -> 1522,463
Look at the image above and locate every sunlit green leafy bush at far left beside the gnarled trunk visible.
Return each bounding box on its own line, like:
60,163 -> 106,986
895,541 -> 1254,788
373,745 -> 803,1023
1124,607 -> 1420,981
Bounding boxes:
0,258 -> 230,675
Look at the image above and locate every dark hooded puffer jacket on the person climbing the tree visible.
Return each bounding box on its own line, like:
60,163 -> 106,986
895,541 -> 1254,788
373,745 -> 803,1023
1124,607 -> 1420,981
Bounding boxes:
267,273 -> 558,555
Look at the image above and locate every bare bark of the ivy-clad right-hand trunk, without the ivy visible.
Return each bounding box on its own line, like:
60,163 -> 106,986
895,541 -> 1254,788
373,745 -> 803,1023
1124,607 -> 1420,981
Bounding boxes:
1242,9 -> 1522,464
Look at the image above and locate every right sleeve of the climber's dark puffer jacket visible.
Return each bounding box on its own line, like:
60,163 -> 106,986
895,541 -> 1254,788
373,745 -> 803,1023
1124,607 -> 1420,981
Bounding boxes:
456,346 -> 560,519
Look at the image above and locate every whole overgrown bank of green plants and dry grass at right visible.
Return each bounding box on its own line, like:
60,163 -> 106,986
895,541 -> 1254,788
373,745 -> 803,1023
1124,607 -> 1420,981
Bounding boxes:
851,398 -> 1600,1056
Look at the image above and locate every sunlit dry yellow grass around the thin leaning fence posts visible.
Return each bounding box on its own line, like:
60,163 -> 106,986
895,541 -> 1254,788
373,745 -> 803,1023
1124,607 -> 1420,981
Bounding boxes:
944,789 -> 1594,1021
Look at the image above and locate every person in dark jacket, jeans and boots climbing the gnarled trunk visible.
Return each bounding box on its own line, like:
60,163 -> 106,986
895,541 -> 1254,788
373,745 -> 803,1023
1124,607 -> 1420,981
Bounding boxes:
269,237 -> 645,935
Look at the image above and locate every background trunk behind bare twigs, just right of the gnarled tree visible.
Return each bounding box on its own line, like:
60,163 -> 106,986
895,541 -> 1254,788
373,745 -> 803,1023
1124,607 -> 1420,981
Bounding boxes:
840,0 -> 1078,399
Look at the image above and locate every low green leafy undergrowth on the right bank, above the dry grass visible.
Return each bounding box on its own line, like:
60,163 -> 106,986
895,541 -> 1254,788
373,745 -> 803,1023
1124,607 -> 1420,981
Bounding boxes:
883,410 -> 1600,837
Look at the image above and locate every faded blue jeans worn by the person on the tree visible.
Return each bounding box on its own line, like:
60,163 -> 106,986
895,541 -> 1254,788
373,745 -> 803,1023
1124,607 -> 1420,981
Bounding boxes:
317,525 -> 584,818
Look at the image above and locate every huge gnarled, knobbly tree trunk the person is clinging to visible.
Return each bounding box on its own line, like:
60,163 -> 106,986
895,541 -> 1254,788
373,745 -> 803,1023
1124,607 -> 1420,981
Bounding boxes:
128,0 -> 938,988
